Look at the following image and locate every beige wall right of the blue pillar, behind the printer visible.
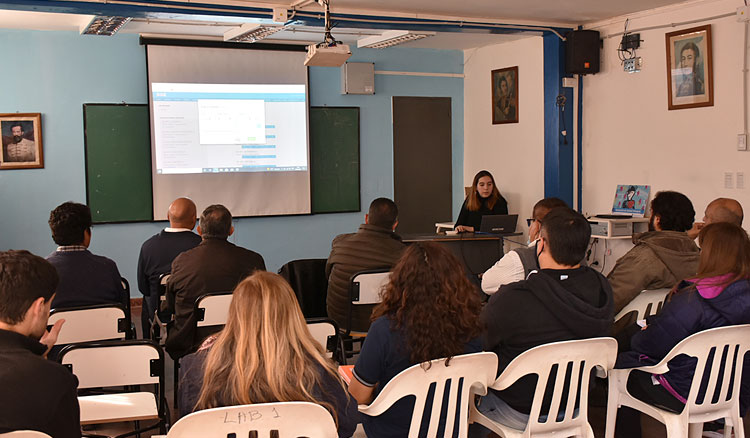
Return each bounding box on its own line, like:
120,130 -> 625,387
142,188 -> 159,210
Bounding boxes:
583,0 -> 750,220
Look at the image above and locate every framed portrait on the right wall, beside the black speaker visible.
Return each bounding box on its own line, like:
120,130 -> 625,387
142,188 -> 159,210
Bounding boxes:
666,24 -> 714,110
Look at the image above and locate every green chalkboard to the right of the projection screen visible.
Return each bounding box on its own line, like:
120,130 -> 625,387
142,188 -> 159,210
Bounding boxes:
310,107 -> 360,213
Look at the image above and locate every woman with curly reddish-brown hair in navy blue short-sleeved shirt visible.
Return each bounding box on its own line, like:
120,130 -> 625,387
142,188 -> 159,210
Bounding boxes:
349,243 -> 481,438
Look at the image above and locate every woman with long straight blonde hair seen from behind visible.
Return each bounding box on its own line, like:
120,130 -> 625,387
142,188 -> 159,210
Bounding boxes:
179,271 -> 359,437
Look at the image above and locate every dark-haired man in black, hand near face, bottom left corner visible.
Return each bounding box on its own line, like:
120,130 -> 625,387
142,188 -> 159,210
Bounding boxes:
0,251 -> 81,438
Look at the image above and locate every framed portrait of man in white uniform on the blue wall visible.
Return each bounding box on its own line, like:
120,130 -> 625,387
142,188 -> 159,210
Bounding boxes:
0,113 -> 44,170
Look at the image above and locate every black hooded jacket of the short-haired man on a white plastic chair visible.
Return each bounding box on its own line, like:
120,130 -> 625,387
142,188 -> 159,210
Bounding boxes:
482,267 -> 613,414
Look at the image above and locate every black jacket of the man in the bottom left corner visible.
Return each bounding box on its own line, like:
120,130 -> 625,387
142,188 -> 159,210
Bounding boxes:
0,330 -> 81,438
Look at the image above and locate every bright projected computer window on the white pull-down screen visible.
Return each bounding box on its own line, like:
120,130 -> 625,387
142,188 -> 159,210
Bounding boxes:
151,82 -> 308,174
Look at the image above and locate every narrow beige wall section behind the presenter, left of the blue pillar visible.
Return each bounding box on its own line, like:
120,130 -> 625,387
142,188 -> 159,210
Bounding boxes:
464,37 -> 544,240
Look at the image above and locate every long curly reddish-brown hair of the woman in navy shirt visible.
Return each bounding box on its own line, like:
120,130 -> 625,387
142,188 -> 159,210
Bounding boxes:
372,242 -> 481,368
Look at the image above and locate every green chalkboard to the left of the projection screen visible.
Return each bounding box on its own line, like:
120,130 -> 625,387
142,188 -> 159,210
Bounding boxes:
83,104 -> 153,223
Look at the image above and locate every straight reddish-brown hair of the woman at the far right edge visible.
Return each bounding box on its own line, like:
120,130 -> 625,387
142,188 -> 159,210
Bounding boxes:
696,222 -> 750,286
